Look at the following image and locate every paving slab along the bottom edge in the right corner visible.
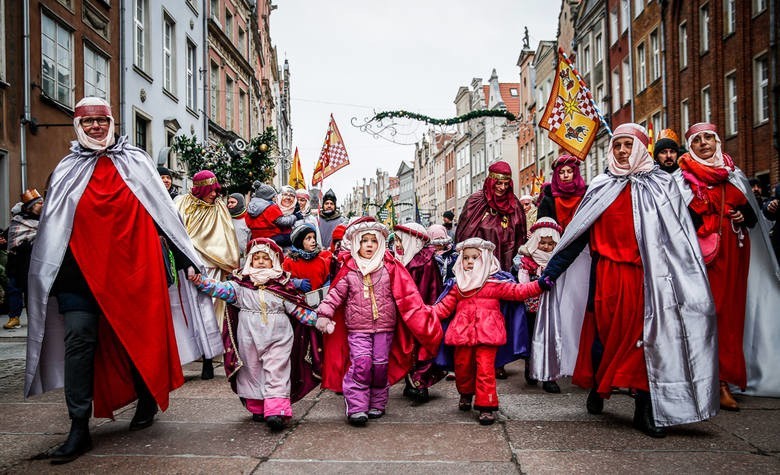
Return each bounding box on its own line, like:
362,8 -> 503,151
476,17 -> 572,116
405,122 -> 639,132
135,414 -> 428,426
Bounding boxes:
517,451 -> 780,475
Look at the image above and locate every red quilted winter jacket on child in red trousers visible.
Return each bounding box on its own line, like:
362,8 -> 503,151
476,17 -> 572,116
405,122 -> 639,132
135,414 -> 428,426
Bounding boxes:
432,279 -> 542,346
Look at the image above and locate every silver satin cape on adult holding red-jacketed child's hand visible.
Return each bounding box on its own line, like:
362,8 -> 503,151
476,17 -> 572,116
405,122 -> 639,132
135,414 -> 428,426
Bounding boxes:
531,166 -> 719,426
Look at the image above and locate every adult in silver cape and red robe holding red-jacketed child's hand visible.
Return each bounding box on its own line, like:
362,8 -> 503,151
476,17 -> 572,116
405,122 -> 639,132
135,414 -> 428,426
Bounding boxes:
531,124 -> 718,437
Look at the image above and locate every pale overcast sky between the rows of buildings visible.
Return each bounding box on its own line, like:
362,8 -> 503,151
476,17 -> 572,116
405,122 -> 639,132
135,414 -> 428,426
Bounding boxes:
270,0 -> 560,201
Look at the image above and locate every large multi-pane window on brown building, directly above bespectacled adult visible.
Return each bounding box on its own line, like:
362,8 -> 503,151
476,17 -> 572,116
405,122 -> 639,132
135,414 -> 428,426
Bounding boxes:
41,14 -> 73,107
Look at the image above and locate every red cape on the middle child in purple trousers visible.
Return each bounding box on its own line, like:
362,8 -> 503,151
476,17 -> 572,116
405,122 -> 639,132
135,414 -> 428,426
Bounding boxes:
322,251 -> 444,392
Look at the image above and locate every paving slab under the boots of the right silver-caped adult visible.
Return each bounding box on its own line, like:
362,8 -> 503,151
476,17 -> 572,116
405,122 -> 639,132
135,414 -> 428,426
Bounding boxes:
506,420 -> 752,454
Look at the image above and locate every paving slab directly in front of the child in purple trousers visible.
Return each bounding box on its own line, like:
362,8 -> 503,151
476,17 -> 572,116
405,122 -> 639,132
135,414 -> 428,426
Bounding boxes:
272,421 -> 512,462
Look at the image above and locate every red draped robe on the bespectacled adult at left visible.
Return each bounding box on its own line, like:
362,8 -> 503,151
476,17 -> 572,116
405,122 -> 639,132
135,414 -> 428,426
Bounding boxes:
70,157 -> 184,417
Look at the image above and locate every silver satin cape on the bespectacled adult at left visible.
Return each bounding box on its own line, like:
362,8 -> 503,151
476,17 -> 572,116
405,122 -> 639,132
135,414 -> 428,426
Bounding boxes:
24,136 -> 224,397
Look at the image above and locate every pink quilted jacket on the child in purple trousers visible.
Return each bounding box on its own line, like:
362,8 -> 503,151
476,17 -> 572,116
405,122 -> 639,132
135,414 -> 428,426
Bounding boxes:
317,266 -> 397,333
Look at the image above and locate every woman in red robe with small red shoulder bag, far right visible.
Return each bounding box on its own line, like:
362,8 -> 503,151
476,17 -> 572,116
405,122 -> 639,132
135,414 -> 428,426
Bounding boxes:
679,123 -> 757,411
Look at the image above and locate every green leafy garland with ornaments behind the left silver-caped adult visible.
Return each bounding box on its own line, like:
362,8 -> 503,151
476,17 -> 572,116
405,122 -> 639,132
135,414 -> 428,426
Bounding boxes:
171,127 -> 276,193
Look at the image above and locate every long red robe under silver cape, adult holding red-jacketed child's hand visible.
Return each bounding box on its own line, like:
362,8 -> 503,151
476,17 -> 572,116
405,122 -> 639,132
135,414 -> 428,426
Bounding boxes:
572,186 -> 650,398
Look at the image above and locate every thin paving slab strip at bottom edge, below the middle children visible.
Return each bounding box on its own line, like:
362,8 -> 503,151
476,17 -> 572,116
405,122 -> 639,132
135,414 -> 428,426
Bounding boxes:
257,460 -> 517,475
